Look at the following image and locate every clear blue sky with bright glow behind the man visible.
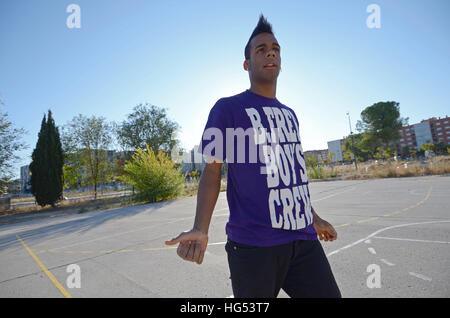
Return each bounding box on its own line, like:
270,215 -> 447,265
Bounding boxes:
0,0 -> 450,177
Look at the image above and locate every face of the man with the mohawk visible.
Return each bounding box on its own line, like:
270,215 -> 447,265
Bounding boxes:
244,33 -> 281,83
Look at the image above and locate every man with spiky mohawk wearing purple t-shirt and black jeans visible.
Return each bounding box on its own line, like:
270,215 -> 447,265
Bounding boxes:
166,15 -> 341,298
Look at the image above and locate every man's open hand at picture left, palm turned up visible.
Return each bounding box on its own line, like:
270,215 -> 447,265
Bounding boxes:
165,229 -> 208,264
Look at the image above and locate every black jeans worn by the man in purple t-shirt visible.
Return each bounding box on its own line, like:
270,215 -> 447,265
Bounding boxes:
225,240 -> 341,298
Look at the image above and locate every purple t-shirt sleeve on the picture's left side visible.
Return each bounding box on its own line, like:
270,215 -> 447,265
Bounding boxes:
197,98 -> 231,162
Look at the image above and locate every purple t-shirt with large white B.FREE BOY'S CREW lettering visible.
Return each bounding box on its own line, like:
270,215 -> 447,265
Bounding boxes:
198,90 -> 317,246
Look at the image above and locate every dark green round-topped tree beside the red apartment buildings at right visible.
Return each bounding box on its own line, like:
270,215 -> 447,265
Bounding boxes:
356,101 -> 408,148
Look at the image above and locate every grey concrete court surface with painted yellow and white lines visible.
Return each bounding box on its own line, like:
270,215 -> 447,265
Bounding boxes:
0,176 -> 450,298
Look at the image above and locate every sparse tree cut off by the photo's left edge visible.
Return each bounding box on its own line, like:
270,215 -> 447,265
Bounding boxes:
0,99 -> 29,194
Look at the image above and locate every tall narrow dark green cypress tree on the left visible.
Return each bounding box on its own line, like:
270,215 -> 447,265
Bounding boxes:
30,110 -> 64,207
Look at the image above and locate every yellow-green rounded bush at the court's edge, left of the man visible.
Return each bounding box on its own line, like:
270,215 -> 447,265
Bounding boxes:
119,145 -> 184,202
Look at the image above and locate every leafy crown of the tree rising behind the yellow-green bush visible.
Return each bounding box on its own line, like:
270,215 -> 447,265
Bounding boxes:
116,103 -> 179,154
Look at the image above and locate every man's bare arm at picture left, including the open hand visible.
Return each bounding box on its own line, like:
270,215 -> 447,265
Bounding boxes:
166,162 -> 222,264
